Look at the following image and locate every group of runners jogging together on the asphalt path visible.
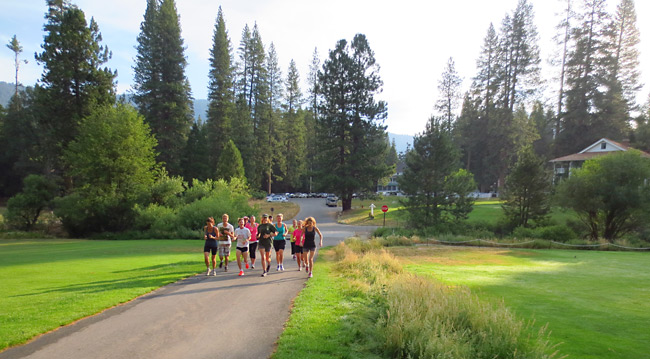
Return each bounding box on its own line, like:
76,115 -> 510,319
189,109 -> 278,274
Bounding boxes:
203,214 -> 323,278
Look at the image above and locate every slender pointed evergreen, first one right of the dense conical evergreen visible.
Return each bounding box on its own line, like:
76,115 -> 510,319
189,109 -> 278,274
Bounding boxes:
207,7 -> 235,176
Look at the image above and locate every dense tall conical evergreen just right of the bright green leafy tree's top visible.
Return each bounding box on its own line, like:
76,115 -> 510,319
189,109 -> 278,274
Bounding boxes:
134,0 -> 193,175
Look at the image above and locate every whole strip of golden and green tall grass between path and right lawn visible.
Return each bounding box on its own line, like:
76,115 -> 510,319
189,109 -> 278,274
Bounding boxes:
334,238 -> 557,359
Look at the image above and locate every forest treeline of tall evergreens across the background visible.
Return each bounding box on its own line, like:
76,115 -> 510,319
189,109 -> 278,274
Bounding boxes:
0,0 -> 650,236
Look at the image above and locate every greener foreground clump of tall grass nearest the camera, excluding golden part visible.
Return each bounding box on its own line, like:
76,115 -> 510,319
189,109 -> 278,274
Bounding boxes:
376,274 -> 557,359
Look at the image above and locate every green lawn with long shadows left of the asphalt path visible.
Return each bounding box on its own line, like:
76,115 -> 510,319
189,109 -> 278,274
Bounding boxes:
0,240 -> 210,350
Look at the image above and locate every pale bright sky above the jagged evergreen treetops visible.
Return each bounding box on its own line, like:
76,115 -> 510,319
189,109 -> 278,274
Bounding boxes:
0,0 -> 650,135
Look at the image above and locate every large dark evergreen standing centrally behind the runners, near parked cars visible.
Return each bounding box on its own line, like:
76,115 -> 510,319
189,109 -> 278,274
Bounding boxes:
317,34 -> 391,211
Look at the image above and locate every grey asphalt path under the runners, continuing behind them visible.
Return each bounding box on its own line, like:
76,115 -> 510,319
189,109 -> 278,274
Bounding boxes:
0,199 -> 372,359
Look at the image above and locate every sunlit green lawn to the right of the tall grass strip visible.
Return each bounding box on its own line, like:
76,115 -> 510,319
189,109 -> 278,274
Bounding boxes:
391,247 -> 650,359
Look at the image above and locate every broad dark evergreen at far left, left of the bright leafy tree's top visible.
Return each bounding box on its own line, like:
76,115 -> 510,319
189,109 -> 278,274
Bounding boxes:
36,0 -> 116,177
